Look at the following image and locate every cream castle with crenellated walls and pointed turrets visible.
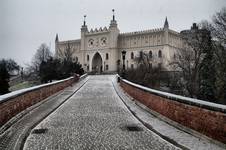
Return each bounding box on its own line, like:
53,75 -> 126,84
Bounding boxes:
55,10 -> 183,73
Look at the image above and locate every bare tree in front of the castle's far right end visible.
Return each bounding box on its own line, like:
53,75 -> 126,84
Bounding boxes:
170,29 -> 206,97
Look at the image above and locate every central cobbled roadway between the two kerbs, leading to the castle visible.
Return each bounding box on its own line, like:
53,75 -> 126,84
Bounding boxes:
24,75 -> 178,150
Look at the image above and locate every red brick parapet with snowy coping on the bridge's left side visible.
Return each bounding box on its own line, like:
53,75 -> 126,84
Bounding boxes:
0,76 -> 84,127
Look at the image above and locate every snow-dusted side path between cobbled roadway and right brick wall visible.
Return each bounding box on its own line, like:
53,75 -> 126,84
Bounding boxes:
113,79 -> 225,150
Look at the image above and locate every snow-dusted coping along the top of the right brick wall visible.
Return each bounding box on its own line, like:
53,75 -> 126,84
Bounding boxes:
121,75 -> 226,113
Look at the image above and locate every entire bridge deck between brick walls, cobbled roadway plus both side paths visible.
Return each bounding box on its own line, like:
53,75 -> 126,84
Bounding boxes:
0,75 -> 224,150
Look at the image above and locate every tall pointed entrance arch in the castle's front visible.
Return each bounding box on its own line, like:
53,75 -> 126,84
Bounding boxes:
92,52 -> 103,73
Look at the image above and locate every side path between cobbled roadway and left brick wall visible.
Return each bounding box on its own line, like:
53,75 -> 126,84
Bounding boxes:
0,79 -> 87,150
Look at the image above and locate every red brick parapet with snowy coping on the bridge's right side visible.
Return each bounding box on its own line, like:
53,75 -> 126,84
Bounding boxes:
120,80 -> 226,143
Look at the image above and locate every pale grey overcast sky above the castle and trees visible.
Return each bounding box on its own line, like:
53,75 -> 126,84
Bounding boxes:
0,0 -> 226,65
